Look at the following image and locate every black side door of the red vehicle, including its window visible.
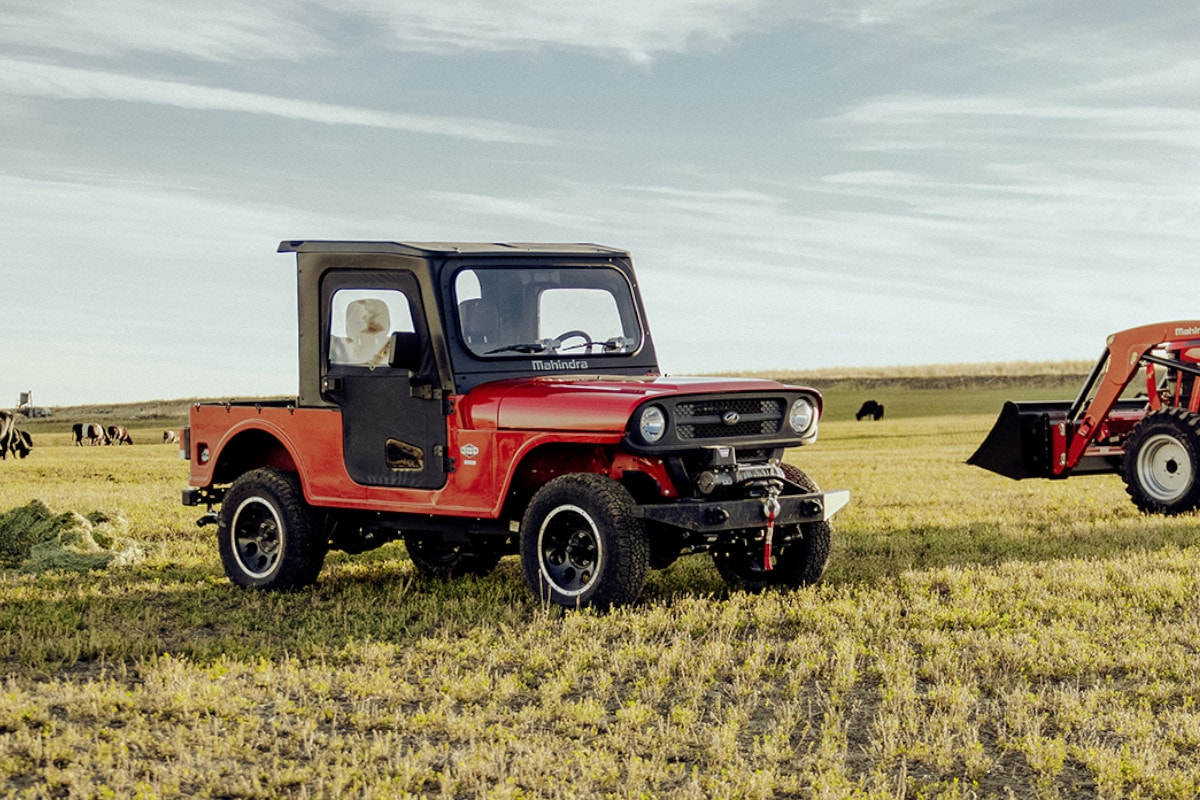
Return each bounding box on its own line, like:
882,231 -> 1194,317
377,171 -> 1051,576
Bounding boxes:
320,270 -> 446,489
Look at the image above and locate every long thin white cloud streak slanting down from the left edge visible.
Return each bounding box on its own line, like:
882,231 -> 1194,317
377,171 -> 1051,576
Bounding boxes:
0,58 -> 556,145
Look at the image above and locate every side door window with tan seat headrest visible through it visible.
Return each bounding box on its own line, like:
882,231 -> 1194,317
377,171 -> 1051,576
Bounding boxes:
329,289 -> 415,368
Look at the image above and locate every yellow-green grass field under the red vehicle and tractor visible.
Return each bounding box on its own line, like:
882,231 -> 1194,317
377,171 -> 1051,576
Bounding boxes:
0,378 -> 1200,799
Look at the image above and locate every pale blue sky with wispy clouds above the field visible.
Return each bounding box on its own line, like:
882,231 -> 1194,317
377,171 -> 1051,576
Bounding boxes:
0,0 -> 1200,407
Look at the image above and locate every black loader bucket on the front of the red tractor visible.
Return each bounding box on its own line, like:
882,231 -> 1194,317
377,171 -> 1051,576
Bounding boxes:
967,401 -> 1072,481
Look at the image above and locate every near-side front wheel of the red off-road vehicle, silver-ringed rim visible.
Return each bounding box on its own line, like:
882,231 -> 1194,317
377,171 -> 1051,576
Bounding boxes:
521,473 -> 650,608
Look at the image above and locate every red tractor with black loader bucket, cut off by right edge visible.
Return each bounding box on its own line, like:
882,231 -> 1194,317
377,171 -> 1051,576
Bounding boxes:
967,320 -> 1200,515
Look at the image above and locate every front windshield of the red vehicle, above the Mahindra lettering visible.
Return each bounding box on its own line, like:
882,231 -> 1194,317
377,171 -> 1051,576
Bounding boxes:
454,266 -> 642,357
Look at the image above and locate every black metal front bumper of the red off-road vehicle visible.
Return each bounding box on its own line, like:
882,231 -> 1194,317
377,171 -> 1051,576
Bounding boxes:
634,489 -> 850,534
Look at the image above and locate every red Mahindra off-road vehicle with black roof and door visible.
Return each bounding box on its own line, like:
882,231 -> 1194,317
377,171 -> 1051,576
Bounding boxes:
180,241 -> 850,606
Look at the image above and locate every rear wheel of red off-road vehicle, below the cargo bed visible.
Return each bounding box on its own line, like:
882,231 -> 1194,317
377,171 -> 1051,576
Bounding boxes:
217,469 -> 328,589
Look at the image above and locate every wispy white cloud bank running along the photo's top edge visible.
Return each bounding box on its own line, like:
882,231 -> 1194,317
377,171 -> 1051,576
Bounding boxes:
0,0 -> 763,62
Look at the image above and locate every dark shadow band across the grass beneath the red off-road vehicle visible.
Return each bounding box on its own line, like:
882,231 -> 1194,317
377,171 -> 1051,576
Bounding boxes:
0,515 -> 1200,676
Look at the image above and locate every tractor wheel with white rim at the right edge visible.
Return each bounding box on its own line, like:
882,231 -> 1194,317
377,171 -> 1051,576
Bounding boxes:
1121,408 -> 1200,516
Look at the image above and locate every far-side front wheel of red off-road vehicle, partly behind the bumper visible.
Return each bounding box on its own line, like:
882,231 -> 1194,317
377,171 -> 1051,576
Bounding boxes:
713,464 -> 833,591
